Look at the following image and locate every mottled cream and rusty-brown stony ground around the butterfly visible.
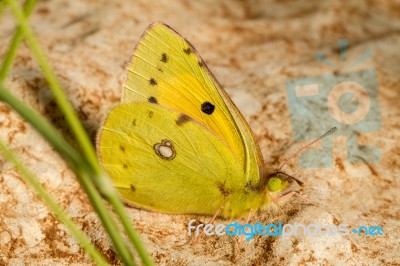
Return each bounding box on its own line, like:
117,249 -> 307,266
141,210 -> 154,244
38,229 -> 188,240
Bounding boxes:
0,0 -> 400,265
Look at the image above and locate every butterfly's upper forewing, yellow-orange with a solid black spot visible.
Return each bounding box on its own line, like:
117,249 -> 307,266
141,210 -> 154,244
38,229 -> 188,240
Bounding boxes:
122,23 -> 263,183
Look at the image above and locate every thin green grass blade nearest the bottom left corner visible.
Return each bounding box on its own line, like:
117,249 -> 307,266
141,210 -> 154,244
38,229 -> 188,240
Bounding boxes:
0,141 -> 108,265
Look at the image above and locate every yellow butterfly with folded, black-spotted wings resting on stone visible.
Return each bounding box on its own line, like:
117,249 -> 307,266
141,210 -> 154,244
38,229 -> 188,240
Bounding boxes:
97,23 -> 300,218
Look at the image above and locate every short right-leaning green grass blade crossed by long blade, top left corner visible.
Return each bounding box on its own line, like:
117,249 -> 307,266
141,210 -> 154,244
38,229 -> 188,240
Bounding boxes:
0,0 -> 36,83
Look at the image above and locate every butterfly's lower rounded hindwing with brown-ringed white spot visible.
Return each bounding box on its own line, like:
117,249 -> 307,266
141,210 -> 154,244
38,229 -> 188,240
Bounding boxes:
97,103 -> 248,215
